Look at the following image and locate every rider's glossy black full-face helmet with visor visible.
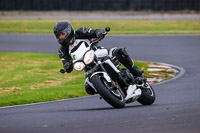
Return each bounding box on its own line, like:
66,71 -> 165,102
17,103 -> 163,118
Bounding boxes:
53,21 -> 74,46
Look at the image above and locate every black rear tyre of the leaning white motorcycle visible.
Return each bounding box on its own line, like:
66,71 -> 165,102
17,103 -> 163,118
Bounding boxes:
137,83 -> 156,105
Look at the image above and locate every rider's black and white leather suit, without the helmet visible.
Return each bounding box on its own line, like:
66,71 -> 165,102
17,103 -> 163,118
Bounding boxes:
58,27 -> 143,76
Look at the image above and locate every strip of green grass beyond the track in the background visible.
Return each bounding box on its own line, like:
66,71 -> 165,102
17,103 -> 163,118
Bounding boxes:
0,20 -> 200,34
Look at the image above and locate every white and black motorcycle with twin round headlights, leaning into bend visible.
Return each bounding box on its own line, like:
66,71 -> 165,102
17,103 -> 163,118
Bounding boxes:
60,27 -> 156,108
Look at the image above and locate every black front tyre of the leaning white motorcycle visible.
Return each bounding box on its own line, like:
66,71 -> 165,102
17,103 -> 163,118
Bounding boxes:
91,74 -> 125,108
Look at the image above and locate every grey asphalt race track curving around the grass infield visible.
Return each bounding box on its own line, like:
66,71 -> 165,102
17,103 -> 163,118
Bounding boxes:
0,35 -> 200,133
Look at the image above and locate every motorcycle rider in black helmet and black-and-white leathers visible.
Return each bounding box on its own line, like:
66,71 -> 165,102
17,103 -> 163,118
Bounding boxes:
53,21 -> 144,99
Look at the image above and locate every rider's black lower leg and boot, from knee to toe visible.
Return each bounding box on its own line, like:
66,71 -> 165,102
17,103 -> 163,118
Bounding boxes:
113,48 -> 144,77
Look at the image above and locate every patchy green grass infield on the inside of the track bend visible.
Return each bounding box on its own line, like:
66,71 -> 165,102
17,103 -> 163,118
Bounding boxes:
0,53 -> 147,106
